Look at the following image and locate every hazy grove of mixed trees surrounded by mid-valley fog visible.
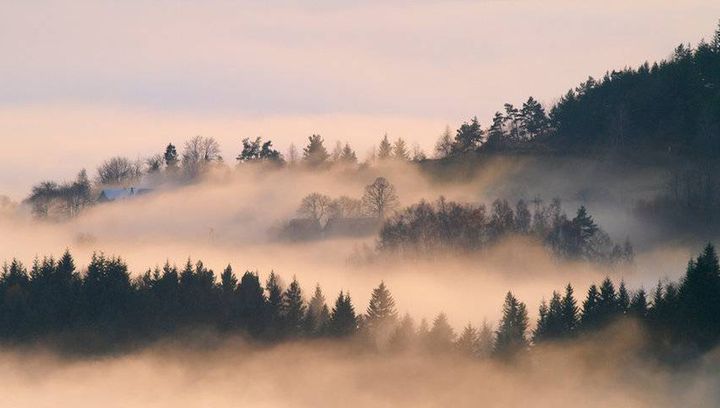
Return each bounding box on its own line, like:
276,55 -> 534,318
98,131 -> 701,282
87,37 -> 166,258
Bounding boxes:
378,197 -> 634,264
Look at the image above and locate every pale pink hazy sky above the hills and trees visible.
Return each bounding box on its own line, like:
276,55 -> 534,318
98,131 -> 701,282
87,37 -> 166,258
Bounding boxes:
0,0 -> 720,198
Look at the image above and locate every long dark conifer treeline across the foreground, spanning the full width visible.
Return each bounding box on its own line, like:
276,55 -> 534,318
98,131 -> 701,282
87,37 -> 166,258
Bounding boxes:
0,244 -> 720,357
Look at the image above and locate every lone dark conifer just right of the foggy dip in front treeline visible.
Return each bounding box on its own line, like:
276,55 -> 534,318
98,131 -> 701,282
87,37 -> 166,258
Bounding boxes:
495,292 -> 528,357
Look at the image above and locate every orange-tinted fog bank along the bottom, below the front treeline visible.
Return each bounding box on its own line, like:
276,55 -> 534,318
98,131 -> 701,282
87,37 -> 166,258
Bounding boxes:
0,324 -> 720,408
